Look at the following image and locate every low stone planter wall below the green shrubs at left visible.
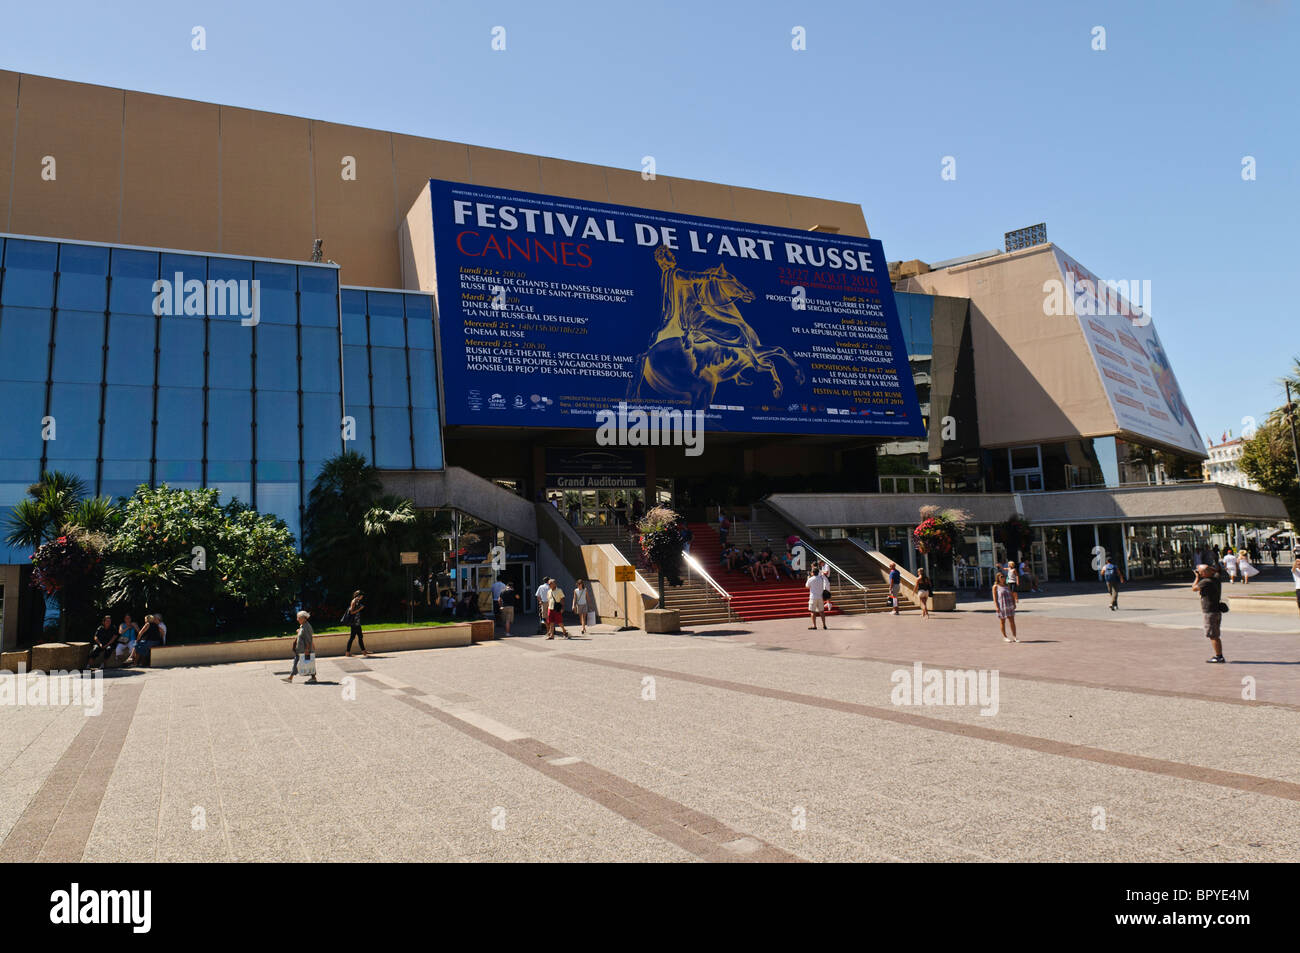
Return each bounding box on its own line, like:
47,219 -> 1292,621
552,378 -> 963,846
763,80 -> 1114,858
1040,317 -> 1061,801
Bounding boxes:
150,619 -> 478,668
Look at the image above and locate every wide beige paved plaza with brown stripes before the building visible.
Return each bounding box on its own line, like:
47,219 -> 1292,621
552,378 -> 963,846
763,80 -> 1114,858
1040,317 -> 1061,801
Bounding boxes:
0,586 -> 1300,862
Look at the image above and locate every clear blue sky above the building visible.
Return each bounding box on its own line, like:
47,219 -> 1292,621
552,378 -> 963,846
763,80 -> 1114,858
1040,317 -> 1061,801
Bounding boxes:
0,0 -> 1300,438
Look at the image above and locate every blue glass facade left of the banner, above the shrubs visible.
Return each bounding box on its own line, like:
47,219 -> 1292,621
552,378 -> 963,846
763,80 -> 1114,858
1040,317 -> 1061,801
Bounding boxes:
0,238 -> 442,563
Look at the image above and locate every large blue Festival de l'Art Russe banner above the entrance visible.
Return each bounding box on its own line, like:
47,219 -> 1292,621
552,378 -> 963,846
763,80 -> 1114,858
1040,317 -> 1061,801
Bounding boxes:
429,179 -> 924,437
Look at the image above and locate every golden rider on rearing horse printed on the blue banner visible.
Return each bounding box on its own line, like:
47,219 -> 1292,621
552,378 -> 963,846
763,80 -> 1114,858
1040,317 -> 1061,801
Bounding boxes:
628,246 -> 806,410
